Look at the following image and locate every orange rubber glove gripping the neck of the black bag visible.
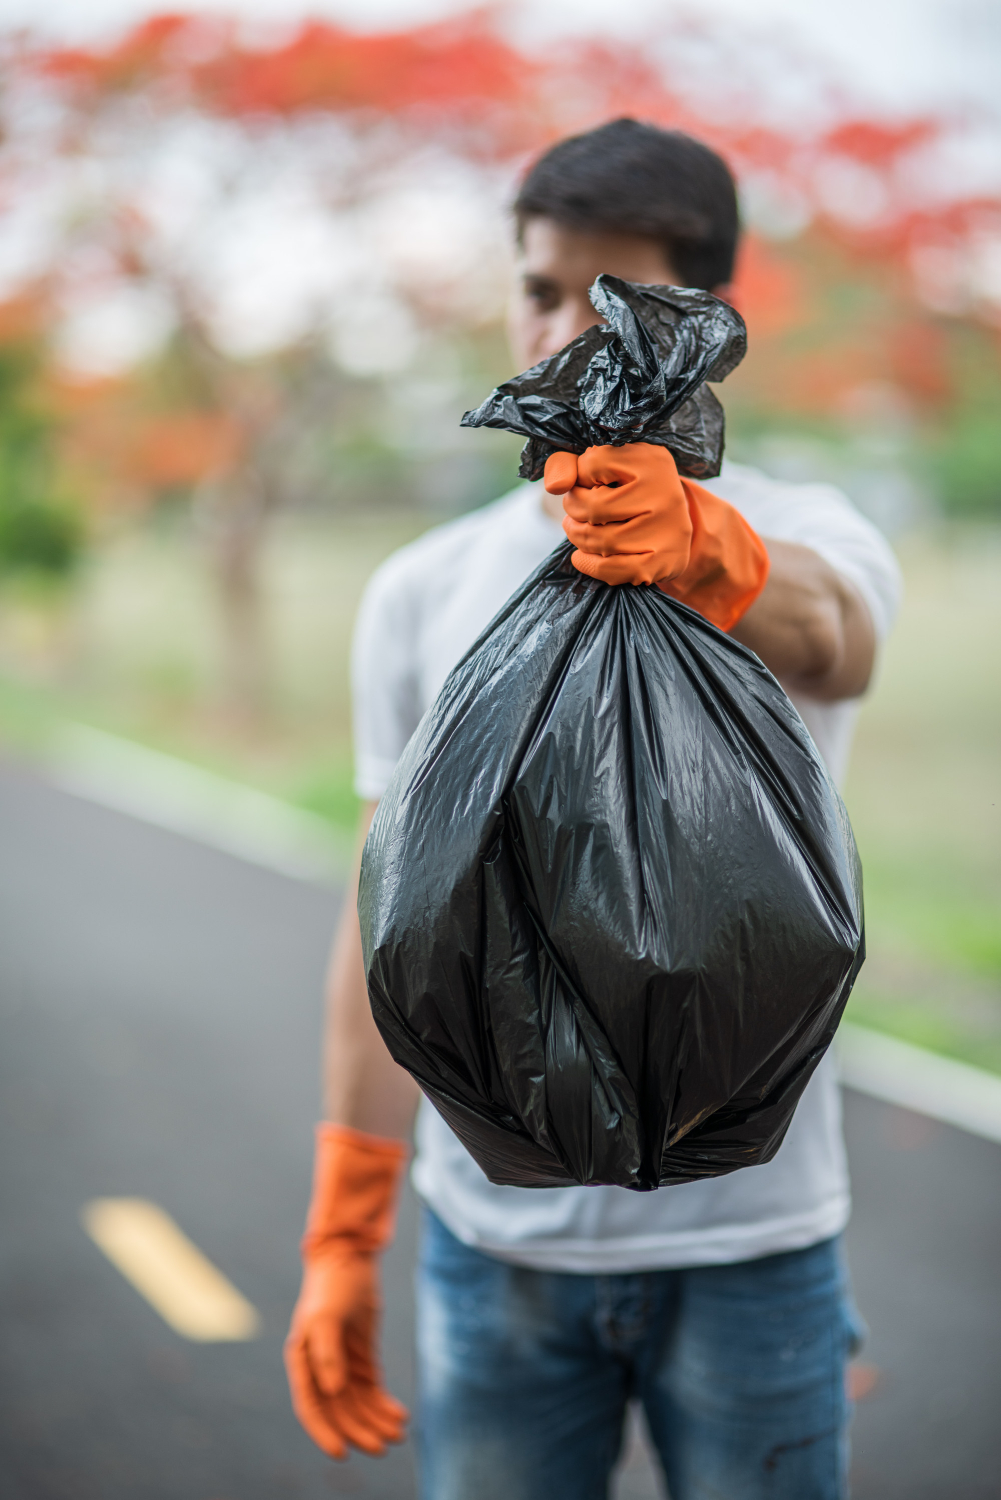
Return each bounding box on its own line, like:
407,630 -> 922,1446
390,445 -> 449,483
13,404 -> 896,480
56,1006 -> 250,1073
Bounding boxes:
545,443 -> 768,630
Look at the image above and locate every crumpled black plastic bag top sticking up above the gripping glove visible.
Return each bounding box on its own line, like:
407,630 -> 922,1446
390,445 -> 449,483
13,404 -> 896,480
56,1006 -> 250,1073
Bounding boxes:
462,276 -> 747,479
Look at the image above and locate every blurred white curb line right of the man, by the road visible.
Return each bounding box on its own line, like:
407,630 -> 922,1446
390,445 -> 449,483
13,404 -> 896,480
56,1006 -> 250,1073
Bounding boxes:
834,1023 -> 1001,1142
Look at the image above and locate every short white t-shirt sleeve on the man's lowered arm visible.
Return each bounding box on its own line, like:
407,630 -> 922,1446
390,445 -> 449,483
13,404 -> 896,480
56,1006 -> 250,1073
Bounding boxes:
351,558 -> 420,801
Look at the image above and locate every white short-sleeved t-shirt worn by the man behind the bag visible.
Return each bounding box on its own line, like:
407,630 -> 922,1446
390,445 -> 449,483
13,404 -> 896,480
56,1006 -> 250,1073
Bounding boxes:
351,464 -> 900,1274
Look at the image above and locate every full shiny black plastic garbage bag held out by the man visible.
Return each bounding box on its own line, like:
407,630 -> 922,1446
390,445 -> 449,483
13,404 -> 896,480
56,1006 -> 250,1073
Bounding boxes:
359,278 -> 863,1190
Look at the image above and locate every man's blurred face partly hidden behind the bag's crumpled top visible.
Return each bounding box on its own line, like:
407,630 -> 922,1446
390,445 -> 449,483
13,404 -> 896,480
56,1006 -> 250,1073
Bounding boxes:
507,219 -> 680,371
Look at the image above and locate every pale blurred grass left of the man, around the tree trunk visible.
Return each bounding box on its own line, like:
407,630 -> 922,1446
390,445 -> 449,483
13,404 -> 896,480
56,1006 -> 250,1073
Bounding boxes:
0,512 -> 429,830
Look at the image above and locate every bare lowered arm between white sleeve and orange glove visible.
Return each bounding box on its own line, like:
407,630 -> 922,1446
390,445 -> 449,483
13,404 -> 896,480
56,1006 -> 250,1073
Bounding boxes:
324,804 -> 420,1139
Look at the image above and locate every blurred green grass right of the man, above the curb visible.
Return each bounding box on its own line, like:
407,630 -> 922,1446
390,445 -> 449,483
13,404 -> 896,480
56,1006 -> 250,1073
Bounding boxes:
846,531 -> 1001,1071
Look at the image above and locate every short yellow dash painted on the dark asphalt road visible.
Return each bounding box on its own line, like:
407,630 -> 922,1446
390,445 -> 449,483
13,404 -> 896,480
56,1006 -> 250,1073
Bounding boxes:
80,1199 -> 260,1343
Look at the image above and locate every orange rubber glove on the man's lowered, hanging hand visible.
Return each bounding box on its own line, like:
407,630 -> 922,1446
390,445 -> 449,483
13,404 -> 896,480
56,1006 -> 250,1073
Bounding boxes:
285,1125 -> 410,1458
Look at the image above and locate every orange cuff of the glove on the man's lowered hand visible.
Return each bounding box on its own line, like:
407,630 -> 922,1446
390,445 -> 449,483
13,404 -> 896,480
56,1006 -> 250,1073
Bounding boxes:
302,1124 -> 408,1260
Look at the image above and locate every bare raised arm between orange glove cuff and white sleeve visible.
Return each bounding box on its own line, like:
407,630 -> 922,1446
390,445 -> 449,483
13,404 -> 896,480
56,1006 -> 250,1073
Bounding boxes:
729,537 -> 876,702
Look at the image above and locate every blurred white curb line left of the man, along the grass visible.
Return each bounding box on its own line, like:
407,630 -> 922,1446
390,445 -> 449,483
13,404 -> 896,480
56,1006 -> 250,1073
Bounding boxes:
45,725 -> 351,881
